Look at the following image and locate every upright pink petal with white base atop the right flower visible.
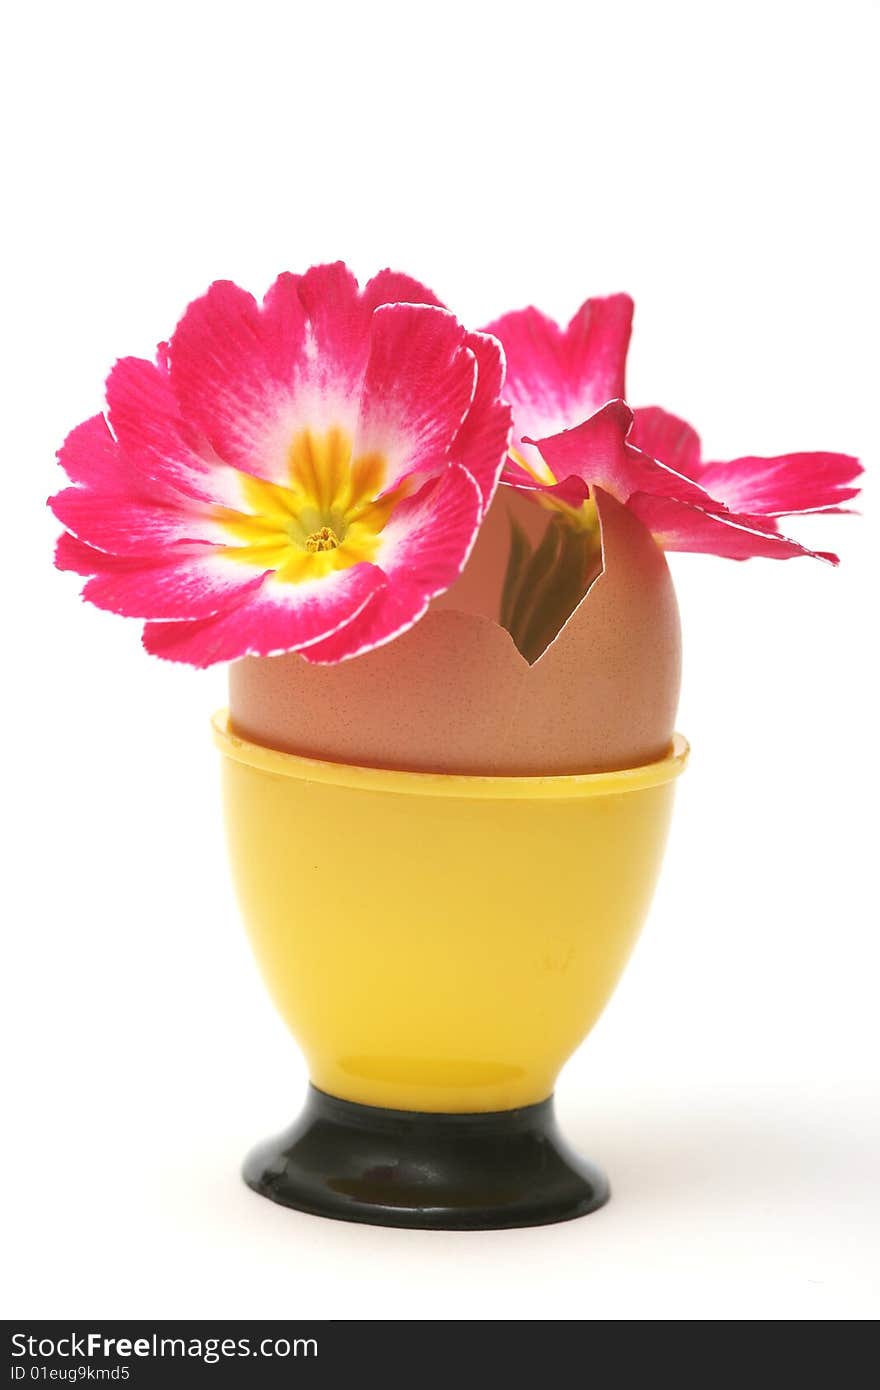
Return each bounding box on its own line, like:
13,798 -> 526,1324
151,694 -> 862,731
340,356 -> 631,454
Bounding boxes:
485,295 -> 633,475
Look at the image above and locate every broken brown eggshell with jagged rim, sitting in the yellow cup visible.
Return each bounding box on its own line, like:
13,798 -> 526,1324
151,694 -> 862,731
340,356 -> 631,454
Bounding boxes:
229,489 -> 681,776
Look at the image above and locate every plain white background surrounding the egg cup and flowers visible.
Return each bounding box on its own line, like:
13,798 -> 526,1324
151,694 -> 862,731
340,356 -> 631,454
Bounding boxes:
0,0 -> 880,1319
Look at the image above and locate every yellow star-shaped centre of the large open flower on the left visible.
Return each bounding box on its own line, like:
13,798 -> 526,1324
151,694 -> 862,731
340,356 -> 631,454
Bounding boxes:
217,428 -> 407,584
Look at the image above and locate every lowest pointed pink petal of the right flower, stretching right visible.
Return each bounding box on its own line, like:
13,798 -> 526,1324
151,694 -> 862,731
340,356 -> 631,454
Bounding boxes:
627,492 -> 838,564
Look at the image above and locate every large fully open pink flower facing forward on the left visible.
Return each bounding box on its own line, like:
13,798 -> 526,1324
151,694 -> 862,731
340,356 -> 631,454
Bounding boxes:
50,264 -> 510,666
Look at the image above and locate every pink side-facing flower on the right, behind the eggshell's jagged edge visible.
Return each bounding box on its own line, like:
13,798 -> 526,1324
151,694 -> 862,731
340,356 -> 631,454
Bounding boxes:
487,295 -> 862,564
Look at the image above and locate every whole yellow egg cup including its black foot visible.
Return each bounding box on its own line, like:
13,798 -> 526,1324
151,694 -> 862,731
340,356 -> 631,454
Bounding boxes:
214,714 -> 688,1230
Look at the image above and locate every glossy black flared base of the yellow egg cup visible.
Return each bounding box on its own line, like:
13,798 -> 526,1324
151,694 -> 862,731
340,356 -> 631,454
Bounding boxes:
243,1086 -> 610,1230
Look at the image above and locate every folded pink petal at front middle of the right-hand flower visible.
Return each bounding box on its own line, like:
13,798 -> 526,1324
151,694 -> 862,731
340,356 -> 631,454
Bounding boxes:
527,400 -> 710,502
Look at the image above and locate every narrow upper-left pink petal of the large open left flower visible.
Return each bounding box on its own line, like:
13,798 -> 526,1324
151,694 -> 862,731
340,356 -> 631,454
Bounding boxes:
107,357 -> 236,506
